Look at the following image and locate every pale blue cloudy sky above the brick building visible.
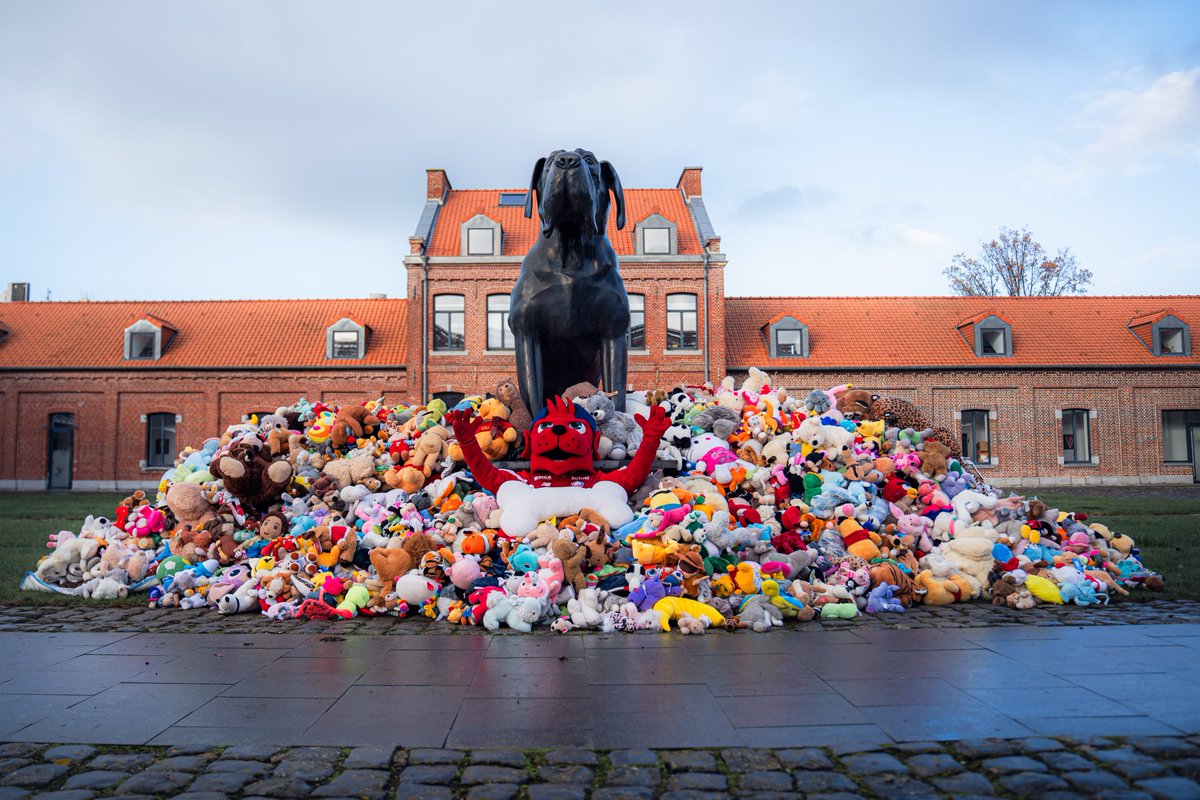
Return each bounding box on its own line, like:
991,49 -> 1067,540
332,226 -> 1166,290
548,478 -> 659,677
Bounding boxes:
0,0 -> 1200,300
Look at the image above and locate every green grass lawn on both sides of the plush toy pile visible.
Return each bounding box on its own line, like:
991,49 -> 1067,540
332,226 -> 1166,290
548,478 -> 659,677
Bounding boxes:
0,489 -> 1200,604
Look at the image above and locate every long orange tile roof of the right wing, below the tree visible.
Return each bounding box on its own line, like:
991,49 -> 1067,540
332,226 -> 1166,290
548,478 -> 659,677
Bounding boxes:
725,295 -> 1200,369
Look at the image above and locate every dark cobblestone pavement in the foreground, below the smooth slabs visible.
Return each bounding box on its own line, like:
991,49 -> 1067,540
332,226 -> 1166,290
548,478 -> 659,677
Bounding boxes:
0,736 -> 1200,800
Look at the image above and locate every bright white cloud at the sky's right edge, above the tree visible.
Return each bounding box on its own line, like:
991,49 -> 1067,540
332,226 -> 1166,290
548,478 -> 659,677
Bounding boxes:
1026,67 -> 1200,184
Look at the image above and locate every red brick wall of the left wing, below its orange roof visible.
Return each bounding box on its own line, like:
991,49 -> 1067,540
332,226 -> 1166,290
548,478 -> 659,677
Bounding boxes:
0,371 -> 409,489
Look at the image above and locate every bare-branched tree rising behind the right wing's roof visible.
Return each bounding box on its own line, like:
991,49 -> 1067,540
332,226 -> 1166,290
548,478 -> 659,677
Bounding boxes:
943,228 -> 1092,297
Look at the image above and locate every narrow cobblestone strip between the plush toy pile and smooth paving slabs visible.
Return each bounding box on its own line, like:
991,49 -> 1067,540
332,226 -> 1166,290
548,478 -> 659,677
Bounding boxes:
0,599 -> 1200,636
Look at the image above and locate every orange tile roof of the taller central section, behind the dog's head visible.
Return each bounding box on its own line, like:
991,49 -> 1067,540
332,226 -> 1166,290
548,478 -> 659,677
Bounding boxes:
426,188 -> 702,257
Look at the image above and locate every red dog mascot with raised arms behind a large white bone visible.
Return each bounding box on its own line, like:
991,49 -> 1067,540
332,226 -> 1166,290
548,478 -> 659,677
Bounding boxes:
449,397 -> 667,537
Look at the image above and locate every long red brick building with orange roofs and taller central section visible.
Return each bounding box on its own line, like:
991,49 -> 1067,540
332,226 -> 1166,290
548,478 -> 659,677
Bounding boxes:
0,168 -> 1200,489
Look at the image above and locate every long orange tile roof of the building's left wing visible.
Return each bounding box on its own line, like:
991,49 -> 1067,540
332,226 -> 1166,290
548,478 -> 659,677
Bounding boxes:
0,299 -> 407,369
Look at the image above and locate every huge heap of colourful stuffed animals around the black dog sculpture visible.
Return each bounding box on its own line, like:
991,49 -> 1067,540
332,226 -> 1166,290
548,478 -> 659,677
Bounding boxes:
23,369 -> 1163,633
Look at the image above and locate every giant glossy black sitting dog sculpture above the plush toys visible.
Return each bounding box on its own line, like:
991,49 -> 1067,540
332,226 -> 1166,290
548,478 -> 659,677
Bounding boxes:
509,149 -> 629,410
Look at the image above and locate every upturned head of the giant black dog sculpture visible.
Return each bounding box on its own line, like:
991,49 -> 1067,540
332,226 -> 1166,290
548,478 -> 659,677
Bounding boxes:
526,148 -> 625,236
